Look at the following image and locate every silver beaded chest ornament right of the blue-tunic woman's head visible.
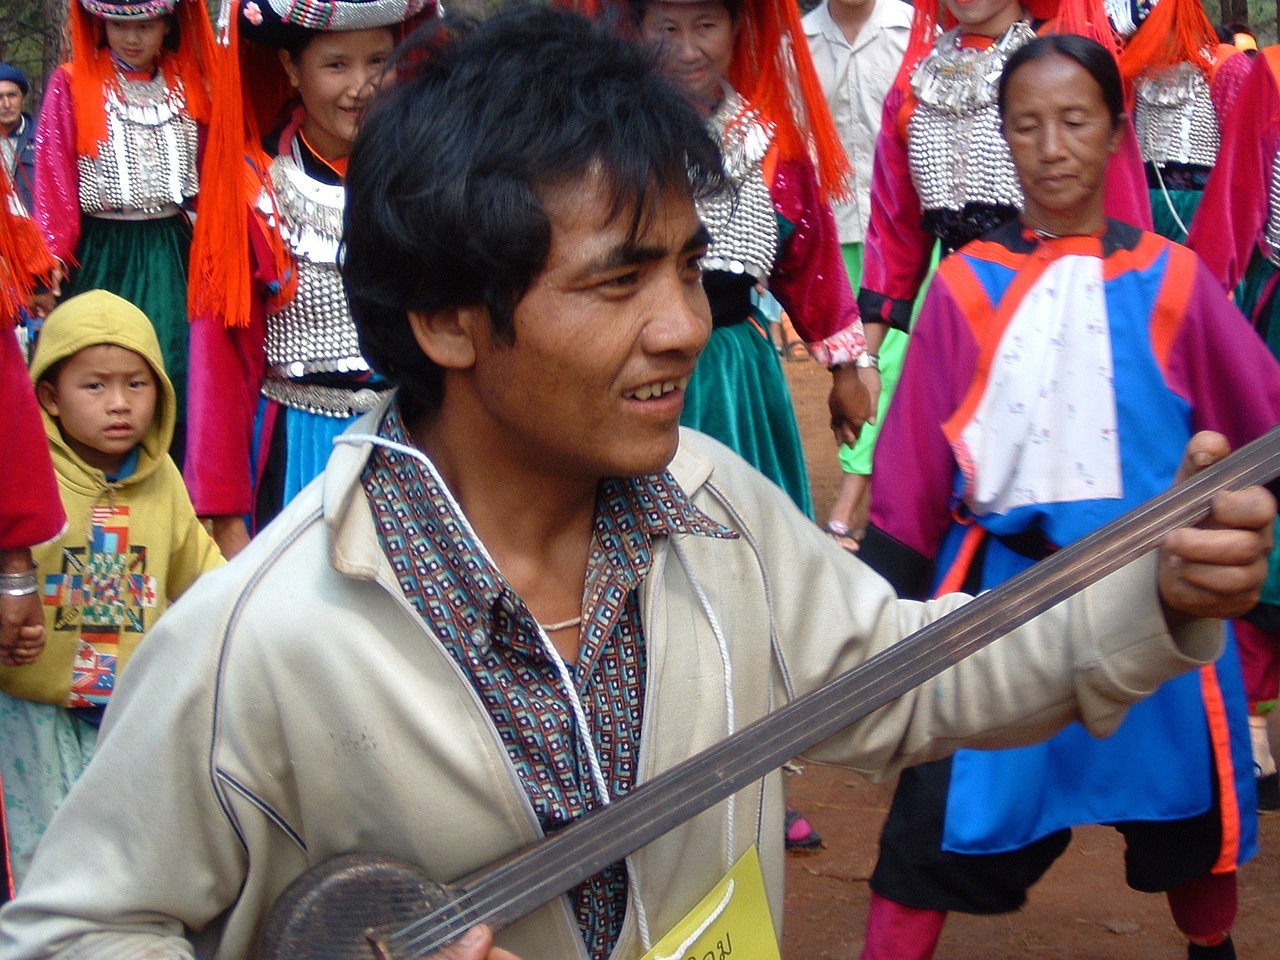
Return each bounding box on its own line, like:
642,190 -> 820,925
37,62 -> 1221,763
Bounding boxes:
1133,63 -> 1219,166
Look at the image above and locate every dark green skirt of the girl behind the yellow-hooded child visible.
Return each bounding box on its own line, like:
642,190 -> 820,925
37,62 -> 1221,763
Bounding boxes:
63,214 -> 191,436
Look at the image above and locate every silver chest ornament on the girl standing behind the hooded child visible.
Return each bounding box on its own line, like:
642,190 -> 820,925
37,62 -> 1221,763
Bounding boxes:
77,72 -> 200,215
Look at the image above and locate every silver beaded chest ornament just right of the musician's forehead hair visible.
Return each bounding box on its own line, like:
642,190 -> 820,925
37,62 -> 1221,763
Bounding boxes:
698,84 -> 778,283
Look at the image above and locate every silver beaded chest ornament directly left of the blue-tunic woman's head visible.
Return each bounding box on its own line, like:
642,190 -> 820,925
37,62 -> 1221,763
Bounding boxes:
906,20 -> 1036,217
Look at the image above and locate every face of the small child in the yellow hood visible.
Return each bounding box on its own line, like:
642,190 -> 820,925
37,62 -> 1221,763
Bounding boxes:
36,343 -> 156,474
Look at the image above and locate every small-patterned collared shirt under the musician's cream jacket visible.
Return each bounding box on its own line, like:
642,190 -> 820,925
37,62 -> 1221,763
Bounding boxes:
361,406 -> 737,960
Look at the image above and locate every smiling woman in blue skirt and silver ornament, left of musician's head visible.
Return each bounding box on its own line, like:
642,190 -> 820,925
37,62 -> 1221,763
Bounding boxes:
186,0 -> 426,556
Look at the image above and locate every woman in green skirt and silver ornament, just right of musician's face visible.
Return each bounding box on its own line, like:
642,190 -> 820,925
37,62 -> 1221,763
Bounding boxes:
631,0 -> 878,516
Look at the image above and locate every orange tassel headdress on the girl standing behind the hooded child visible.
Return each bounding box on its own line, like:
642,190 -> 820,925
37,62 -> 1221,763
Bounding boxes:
68,0 -> 214,156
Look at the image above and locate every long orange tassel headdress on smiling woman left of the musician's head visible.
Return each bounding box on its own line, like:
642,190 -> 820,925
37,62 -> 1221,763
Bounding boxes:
187,0 -> 438,328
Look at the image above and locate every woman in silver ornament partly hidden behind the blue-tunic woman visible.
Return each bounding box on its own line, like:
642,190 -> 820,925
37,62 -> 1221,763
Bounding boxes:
858,0 -> 1151,343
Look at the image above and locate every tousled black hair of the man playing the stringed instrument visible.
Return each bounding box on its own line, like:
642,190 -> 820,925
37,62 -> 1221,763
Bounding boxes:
343,6 -> 723,417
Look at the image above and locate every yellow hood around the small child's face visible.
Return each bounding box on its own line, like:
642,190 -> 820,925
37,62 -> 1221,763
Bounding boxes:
31,291 -> 178,486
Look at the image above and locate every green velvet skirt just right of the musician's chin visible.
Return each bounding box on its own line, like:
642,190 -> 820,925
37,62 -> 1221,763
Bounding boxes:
680,323 -> 813,517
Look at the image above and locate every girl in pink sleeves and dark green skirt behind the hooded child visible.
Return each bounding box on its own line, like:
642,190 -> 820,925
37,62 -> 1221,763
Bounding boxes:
33,0 -> 214,463
